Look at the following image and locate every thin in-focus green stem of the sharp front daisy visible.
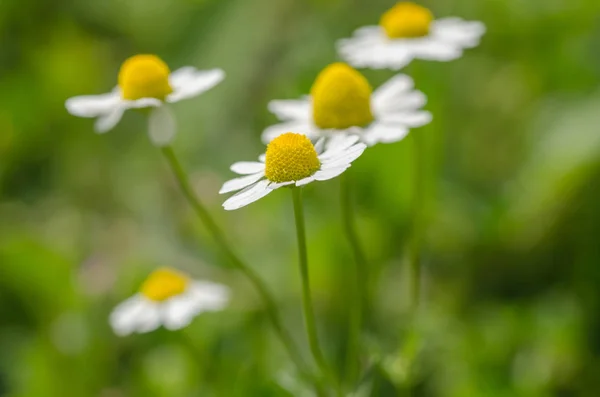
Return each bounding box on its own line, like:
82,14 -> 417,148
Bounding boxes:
291,187 -> 339,392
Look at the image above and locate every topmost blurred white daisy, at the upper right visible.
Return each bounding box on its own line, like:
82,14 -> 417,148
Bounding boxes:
338,2 -> 485,70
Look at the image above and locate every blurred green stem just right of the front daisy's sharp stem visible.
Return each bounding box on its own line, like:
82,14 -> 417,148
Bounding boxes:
340,172 -> 370,382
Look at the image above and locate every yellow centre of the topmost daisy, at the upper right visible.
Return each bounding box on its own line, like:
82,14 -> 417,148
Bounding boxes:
379,2 -> 433,39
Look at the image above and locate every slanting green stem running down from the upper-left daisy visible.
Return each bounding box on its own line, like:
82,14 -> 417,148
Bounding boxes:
161,146 -> 312,386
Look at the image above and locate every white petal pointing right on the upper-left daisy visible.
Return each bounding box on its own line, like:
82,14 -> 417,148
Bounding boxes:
167,67 -> 225,102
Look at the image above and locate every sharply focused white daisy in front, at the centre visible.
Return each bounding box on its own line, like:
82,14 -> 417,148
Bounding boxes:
219,132 -> 367,211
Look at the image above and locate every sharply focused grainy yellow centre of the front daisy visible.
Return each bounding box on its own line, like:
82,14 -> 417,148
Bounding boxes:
265,132 -> 321,183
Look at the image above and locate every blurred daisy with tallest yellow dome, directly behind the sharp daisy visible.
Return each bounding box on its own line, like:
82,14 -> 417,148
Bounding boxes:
262,62 -> 431,146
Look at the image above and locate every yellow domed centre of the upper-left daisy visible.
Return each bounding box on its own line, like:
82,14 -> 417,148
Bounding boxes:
119,55 -> 173,101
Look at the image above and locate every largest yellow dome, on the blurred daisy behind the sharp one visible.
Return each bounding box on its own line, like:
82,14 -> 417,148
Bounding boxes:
310,62 -> 373,129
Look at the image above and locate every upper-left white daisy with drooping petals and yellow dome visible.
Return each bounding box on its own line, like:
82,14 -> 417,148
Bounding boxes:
65,55 -> 225,146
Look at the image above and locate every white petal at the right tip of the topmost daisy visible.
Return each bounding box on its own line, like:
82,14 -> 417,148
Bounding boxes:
431,18 -> 485,48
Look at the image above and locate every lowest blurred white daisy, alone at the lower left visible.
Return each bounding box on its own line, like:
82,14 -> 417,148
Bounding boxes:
110,268 -> 229,336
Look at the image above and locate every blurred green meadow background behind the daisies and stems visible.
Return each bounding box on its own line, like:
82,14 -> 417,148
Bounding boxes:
0,0 -> 600,397
